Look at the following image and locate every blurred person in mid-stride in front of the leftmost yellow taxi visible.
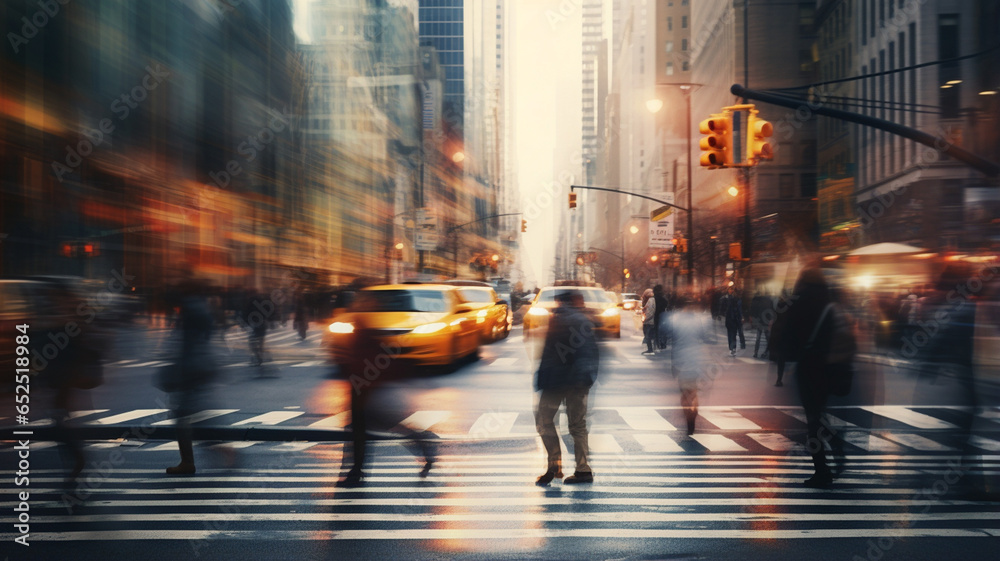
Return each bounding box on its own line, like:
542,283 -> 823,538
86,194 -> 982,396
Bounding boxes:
338,314 -> 436,487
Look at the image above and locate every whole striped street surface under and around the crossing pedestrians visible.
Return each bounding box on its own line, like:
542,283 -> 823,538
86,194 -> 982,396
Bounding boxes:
3,322 -> 1000,559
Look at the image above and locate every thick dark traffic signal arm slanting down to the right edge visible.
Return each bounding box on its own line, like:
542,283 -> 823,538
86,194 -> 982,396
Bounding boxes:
729,84 -> 1000,177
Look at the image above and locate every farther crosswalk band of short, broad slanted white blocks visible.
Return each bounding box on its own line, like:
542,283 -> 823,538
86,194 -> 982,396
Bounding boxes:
9,405 -> 1000,454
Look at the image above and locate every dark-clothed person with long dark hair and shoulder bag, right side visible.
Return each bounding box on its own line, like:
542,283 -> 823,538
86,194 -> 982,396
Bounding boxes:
782,269 -> 844,488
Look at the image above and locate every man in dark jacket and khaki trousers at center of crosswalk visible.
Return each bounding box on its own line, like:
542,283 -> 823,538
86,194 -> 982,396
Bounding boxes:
535,290 -> 600,486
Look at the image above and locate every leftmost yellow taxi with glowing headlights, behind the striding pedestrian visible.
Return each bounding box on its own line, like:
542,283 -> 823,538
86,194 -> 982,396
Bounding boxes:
324,284 -> 481,365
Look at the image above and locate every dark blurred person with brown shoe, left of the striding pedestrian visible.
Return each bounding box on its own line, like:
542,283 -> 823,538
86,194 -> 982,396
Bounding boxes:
158,279 -> 216,475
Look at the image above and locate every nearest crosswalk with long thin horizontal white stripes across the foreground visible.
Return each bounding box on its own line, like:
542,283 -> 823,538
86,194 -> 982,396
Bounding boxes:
7,444 -> 1000,544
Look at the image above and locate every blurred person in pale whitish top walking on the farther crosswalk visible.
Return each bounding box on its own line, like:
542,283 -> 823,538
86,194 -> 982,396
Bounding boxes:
667,298 -> 715,437
